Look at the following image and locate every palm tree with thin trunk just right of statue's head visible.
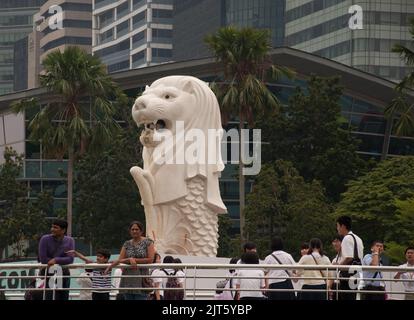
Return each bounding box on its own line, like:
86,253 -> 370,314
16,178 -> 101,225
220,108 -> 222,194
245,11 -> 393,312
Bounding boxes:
205,26 -> 293,241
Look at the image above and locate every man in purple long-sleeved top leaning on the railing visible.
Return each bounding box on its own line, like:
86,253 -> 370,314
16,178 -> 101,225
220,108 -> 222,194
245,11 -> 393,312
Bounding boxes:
39,220 -> 75,300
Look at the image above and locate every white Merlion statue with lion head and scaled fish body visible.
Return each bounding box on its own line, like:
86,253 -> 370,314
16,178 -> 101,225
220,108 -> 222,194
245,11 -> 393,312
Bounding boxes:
131,76 -> 227,257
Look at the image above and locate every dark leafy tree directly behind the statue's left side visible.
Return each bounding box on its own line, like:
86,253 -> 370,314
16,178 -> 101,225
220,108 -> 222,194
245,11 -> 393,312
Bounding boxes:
75,97 -> 145,248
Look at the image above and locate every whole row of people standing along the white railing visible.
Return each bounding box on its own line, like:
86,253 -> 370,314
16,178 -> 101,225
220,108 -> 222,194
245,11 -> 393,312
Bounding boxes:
24,216 -> 414,300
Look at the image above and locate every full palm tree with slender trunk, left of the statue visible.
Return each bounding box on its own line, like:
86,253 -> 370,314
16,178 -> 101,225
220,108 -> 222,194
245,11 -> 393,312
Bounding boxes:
13,47 -> 121,235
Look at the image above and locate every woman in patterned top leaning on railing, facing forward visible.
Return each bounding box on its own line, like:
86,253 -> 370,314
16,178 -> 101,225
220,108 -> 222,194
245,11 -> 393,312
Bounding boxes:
107,221 -> 155,300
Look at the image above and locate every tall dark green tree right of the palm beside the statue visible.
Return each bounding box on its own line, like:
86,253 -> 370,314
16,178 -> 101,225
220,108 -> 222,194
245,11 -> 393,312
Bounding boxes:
256,76 -> 366,201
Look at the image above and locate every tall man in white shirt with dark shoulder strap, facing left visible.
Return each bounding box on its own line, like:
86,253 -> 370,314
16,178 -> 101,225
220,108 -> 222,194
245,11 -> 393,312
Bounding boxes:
336,216 -> 364,300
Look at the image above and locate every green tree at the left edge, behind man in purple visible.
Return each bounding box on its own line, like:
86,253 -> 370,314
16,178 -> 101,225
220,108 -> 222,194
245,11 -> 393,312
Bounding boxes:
0,148 -> 51,257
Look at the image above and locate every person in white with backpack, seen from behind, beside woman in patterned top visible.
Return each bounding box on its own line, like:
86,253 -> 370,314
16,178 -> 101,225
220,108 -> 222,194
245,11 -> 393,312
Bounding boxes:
152,256 -> 185,300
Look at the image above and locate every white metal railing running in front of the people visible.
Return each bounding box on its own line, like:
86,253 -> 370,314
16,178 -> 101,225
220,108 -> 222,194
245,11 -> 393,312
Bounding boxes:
0,263 -> 414,300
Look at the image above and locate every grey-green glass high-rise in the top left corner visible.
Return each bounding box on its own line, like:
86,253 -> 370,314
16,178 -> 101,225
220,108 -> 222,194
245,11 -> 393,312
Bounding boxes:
0,0 -> 46,95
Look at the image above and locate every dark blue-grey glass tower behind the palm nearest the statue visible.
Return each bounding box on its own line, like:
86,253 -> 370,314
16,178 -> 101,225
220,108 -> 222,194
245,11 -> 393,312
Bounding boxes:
173,0 -> 286,61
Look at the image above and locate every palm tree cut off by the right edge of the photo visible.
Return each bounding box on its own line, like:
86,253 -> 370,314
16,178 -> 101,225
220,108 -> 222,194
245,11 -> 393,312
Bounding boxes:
385,18 -> 414,136
